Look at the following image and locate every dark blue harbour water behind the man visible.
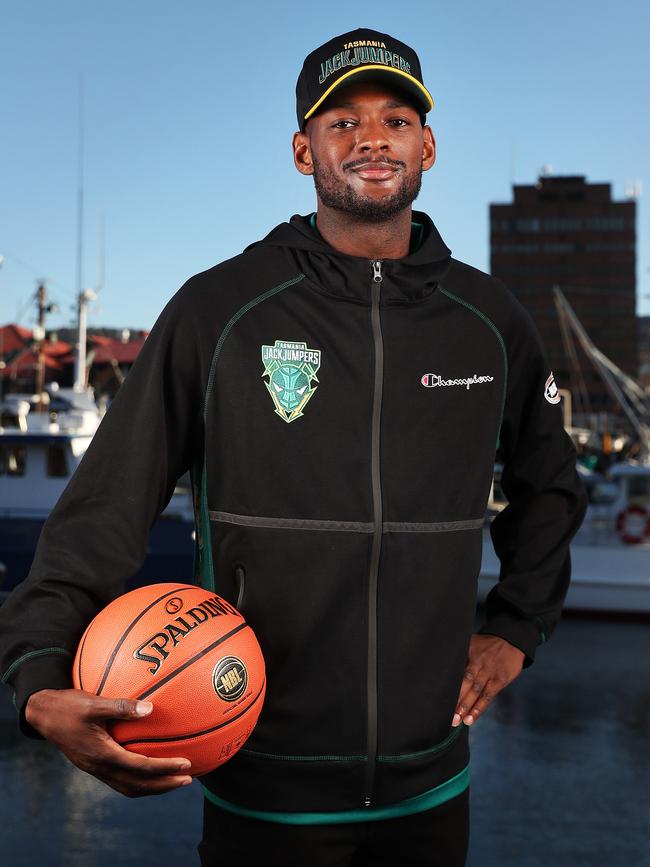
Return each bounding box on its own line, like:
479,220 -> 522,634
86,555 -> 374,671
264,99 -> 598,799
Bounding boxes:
0,619 -> 650,867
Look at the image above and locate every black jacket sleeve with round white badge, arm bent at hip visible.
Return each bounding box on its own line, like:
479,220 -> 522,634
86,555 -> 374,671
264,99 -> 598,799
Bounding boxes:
479,302 -> 587,667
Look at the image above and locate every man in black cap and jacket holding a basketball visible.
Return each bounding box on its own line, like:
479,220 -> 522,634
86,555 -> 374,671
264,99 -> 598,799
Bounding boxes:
1,30 -> 586,867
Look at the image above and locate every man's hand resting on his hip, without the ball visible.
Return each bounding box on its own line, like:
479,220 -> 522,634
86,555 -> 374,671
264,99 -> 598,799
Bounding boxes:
451,634 -> 525,726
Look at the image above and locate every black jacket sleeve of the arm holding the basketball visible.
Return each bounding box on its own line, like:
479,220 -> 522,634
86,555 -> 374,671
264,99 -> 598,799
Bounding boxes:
0,281 -> 205,737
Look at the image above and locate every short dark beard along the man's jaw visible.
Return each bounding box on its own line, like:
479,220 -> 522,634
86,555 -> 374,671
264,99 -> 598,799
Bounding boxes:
312,152 -> 422,223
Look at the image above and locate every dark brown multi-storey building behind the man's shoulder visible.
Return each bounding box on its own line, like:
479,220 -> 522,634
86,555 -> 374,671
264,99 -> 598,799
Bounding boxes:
490,175 -> 639,412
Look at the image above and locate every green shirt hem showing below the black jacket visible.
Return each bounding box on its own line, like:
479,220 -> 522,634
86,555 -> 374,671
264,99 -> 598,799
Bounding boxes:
201,765 -> 469,825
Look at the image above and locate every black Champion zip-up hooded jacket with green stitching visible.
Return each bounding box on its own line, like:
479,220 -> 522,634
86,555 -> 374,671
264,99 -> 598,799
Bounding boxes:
0,212 -> 586,812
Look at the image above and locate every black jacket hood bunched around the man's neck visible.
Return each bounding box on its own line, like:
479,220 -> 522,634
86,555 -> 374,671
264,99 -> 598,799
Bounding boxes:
247,211 -> 451,304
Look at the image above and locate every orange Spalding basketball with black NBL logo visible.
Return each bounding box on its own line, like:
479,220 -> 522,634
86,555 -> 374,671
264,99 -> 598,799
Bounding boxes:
72,584 -> 266,776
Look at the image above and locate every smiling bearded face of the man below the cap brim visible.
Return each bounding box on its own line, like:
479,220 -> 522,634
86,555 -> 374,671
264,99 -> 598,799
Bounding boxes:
293,83 -> 435,222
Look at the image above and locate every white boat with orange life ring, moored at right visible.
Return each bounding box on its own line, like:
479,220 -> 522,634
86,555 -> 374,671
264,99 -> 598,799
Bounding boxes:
478,286 -> 650,615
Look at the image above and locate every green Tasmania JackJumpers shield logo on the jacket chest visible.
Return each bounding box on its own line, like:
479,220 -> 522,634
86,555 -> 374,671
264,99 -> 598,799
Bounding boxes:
262,340 -> 320,422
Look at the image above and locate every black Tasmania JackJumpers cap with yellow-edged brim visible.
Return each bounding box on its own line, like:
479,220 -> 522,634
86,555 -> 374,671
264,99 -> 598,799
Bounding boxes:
296,27 -> 433,130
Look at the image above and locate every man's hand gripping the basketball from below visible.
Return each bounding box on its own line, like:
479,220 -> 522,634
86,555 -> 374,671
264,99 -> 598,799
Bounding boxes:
25,689 -> 192,798
